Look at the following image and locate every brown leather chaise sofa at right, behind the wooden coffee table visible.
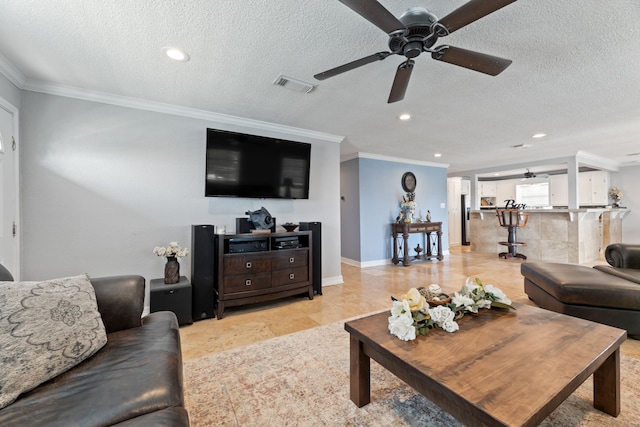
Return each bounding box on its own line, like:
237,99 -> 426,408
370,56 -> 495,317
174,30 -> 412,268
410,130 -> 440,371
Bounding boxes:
520,244 -> 640,338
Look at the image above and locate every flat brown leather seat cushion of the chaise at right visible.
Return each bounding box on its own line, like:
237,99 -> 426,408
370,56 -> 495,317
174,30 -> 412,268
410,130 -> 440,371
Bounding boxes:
520,262 -> 640,310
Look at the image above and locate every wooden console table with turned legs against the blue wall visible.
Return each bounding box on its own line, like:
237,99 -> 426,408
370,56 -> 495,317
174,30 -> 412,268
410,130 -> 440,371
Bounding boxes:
391,222 -> 444,266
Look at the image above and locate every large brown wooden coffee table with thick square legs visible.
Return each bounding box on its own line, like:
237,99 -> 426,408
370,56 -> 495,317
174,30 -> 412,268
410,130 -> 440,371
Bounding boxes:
345,305 -> 627,426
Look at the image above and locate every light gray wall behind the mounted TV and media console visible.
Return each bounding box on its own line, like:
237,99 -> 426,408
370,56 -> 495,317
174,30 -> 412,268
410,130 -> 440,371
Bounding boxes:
21,91 -> 341,292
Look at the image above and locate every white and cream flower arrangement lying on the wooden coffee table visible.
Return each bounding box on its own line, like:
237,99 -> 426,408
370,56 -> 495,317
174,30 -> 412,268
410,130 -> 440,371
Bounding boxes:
389,279 -> 515,341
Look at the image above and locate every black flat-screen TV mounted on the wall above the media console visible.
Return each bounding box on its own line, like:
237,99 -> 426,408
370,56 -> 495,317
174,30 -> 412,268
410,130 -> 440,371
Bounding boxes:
205,129 -> 311,199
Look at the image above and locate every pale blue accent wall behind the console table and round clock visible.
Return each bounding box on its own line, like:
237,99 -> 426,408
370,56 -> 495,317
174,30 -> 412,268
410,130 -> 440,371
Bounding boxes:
340,157 -> 449,264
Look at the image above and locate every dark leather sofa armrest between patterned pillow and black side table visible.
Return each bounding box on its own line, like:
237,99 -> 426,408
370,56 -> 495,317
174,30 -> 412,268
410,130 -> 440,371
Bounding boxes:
91,275 -> 145,334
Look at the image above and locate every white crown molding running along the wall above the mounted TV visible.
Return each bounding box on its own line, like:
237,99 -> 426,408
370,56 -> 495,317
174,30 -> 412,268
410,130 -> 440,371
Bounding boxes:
14,79 -> 344,144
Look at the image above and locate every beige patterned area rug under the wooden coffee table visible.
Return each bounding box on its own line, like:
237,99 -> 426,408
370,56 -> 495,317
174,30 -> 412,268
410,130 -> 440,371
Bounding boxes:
184,322 -> 640,427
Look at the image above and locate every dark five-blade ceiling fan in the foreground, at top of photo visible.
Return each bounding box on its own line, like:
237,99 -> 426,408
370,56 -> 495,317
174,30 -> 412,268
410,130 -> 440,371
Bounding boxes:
314,0 -> 516,103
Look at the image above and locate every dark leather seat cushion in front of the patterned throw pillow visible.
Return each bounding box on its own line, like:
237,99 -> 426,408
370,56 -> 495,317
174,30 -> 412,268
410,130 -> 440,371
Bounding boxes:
0,311 -> 184,427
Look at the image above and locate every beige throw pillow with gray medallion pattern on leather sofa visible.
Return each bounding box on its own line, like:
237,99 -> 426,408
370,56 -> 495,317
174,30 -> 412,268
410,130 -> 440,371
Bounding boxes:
0,274 -> 107,409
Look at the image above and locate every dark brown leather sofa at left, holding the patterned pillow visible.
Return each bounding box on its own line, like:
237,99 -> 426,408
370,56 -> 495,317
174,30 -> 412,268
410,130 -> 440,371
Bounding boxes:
0,265 -> 189,427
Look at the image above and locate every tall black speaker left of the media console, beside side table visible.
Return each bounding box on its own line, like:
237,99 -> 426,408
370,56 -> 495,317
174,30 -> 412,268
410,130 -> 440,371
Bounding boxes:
191,225 -> 216,321
